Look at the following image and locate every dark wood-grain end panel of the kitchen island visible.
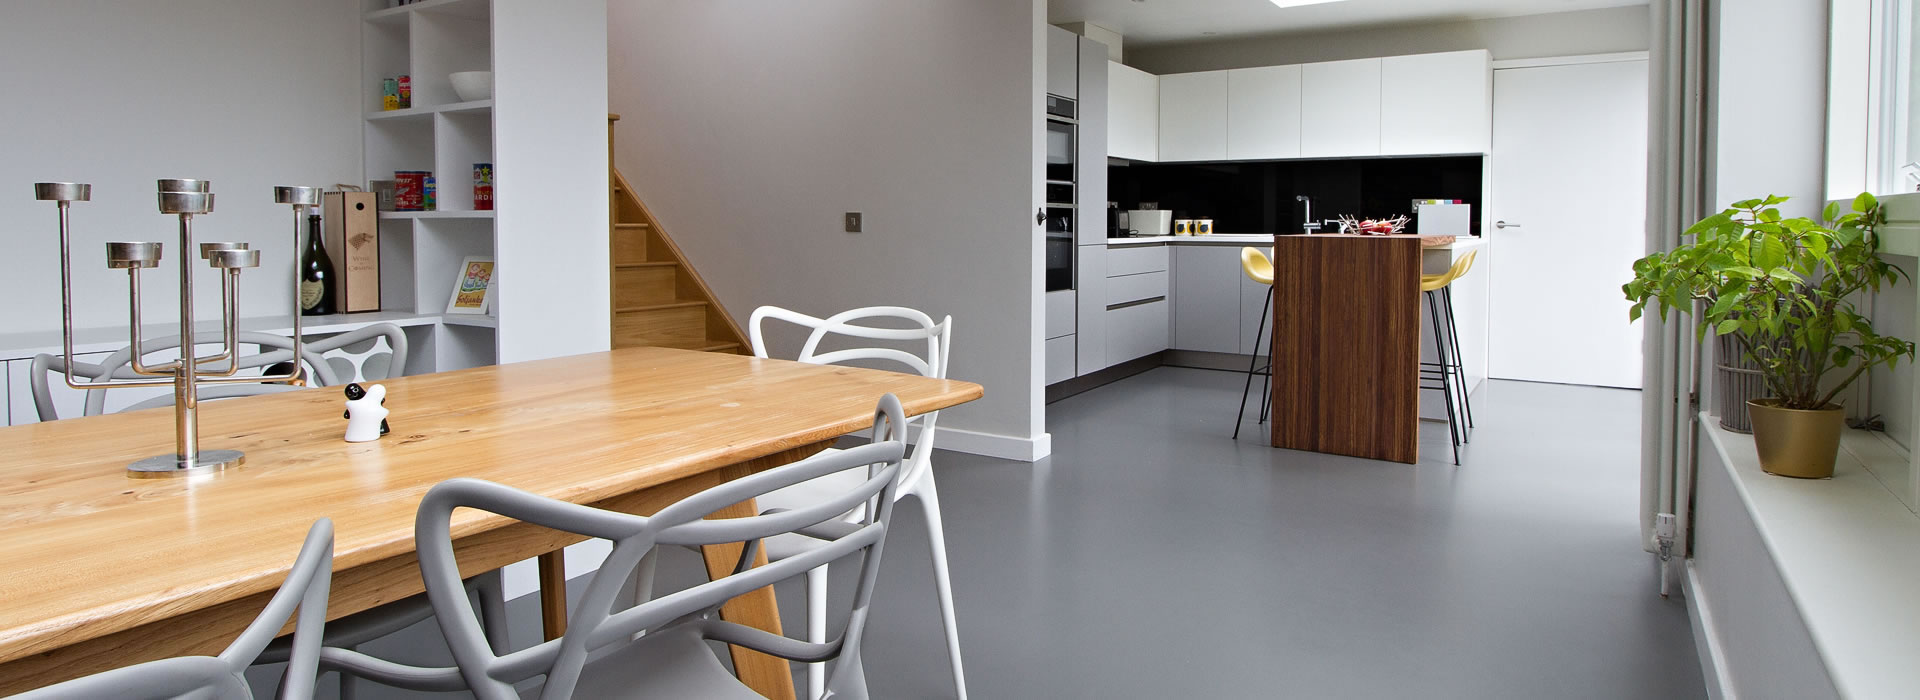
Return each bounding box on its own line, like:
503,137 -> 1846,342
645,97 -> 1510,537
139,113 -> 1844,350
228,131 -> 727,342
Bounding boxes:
1271,234 -> 1423,464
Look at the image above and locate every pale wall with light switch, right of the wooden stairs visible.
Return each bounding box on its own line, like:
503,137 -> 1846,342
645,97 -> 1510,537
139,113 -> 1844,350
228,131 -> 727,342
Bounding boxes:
607,0 -> 1044,447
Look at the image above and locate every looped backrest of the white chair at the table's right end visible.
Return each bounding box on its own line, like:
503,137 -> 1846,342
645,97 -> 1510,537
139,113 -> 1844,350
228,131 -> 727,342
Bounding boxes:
747,307 -> 954,485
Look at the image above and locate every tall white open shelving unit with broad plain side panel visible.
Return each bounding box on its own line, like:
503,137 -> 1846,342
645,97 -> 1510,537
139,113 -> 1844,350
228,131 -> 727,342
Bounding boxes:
351,0 -> 609,370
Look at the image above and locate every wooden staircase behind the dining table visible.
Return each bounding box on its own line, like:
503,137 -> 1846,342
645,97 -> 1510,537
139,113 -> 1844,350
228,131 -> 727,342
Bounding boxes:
607,115 -> 749,355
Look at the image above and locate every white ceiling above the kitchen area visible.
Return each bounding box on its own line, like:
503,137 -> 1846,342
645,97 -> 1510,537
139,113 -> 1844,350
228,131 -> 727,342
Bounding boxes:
1046,0 -> 1647,48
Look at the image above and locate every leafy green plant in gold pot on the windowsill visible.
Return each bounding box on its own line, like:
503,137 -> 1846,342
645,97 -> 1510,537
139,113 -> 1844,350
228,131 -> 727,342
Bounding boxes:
1622,194 -> 1914,478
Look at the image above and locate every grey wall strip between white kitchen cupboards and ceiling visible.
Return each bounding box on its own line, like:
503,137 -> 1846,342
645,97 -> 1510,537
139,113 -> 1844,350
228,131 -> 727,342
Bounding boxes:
1125,6 -> 1649,73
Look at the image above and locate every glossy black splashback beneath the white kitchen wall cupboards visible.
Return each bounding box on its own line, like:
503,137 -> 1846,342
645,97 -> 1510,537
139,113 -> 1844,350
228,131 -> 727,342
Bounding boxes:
1106,155 -> 1486,236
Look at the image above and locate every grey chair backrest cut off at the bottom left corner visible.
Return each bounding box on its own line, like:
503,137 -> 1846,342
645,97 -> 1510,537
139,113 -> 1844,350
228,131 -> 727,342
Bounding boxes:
13,518 -> 334,700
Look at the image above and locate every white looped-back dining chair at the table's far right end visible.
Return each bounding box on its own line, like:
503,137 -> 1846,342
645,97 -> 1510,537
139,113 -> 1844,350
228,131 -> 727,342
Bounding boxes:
747,307 -> 966,700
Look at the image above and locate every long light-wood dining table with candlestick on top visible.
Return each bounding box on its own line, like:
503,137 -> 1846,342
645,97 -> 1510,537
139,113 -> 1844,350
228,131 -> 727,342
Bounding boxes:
0,347 -> 981,698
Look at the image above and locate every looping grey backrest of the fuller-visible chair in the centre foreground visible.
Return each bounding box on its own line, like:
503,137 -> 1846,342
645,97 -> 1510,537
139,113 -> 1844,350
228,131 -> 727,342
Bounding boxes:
395,393 -> 906,700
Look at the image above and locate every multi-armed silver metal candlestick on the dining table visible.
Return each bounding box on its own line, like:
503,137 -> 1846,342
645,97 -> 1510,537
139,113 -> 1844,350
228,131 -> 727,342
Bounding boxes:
33,180 -> 321,478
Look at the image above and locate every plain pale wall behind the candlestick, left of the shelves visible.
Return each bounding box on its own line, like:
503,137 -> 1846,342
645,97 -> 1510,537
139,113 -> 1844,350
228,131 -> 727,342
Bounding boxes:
0,0 -> 363,332
